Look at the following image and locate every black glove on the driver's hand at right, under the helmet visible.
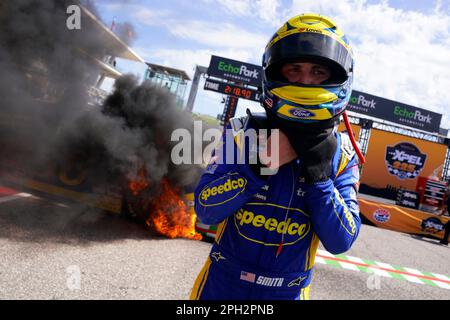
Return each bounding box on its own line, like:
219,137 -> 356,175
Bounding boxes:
297,133 -> 337,184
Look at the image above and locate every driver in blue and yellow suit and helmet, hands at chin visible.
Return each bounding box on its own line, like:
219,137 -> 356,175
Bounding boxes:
190,14 -> 361,300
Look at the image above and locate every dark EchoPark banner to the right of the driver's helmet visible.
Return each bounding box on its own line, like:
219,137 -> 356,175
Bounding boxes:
347,90 -> 442,133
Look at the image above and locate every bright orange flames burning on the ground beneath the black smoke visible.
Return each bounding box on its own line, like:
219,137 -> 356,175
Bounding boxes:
146,179 -> 202,240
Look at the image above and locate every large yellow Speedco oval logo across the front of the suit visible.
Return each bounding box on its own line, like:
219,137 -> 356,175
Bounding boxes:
234,203 -> 311,246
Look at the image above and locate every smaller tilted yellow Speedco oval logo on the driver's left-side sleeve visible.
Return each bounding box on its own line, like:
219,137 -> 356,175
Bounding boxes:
198,174 -> 247,206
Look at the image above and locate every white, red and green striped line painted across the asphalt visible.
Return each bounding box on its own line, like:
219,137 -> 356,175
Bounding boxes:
315,249 -> 450,290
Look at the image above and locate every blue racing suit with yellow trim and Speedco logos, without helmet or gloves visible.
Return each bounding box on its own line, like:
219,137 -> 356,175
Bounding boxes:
190,117 -> 361,300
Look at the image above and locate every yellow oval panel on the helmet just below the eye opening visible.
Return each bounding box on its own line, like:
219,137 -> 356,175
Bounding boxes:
270,86 -> 338,106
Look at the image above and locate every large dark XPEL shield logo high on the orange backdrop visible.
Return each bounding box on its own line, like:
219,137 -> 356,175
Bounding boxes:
386,142 -> 427,180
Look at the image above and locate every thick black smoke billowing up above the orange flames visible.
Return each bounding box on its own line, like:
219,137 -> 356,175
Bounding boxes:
0,0 -> 198,214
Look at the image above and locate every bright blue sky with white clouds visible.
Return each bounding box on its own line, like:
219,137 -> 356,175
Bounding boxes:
94,0 -> 450,128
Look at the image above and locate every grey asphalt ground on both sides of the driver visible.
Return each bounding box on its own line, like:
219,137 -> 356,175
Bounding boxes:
0,189 -> 450,300
